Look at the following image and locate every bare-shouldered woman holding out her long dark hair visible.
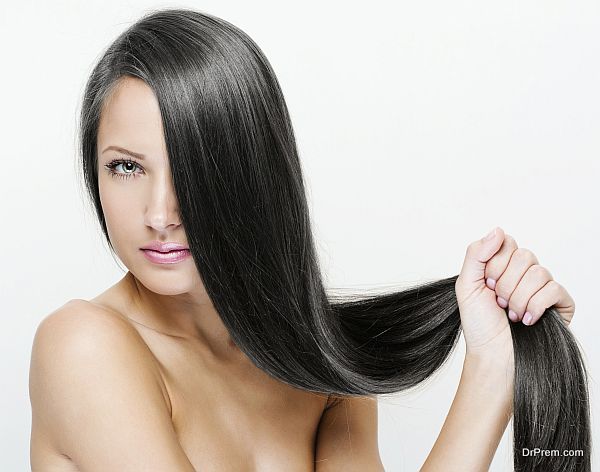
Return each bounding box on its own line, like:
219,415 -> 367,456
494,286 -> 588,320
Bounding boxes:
30,9 -> 590,472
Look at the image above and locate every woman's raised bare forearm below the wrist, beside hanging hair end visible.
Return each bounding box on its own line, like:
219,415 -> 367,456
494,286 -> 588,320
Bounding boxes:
420,353 -> 514,472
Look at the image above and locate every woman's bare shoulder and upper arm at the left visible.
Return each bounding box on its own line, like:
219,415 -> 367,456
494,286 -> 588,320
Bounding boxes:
29,303 -> 194,472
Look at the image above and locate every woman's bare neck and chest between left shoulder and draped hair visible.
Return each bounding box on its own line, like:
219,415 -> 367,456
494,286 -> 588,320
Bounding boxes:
90,272 -> 327,471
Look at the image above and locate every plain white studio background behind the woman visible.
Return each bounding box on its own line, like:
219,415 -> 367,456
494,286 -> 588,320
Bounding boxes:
0,0 -> 600,471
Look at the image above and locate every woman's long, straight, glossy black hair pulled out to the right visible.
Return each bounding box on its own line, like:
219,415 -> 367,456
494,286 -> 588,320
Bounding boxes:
75,9 -> 591,472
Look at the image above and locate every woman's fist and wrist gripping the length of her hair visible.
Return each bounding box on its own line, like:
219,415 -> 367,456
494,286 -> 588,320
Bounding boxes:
455,228 -> 575,366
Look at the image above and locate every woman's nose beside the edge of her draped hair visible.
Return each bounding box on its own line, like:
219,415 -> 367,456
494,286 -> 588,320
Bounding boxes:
144,173 -> 181,232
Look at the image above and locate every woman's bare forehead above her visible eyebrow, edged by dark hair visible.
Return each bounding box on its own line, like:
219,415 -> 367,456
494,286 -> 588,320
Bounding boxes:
98,77 -> 165,156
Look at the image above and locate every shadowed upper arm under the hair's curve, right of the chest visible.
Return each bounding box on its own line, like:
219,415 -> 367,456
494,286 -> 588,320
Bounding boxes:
315,396 -> 384,472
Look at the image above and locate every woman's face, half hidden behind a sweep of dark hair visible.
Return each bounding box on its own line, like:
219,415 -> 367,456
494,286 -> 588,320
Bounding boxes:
97,77 -> 204,295
